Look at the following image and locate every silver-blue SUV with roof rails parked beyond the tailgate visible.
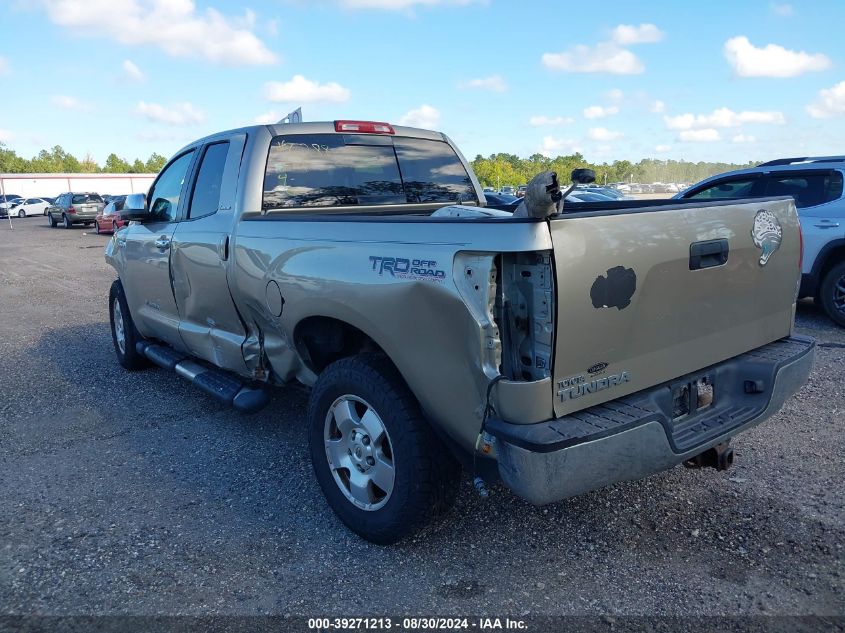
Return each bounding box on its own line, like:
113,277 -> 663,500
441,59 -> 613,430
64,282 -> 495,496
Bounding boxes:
674,156 -> 845,327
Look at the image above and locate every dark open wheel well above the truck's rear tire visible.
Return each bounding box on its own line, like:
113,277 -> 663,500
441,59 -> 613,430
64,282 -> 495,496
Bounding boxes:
293,316 -> 382,373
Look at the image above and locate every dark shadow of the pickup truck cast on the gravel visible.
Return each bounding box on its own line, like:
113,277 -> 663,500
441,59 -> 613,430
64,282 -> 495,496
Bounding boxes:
19,322 -> 845,600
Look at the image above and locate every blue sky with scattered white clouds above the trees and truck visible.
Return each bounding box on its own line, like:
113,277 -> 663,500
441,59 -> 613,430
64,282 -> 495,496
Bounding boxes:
0,0 -> 845,164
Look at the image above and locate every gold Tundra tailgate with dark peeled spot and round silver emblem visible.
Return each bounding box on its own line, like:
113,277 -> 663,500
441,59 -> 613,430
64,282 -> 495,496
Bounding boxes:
550,198 -> 801,416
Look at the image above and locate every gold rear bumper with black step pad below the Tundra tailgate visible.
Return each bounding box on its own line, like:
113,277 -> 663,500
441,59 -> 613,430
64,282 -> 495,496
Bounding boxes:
487,336 -> 815,505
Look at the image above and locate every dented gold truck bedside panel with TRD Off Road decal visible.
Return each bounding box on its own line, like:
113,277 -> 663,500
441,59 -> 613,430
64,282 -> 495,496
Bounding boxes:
227,218 -> 551,450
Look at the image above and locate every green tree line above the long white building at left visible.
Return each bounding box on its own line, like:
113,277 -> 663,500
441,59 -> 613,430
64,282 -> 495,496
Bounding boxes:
0,143 -> 167,174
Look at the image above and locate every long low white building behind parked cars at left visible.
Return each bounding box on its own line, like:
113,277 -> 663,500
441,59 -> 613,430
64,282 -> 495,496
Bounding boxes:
0,174 -> 158,198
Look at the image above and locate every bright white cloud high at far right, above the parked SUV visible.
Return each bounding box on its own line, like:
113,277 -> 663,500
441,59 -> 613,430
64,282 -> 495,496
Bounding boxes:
724,35 -> 832,78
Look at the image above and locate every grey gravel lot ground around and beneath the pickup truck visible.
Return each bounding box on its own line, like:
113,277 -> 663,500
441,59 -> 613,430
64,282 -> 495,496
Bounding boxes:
0,218 -> 845,615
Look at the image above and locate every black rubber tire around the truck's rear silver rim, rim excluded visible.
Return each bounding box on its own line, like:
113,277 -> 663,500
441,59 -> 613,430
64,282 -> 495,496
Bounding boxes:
308,354 -> 461,545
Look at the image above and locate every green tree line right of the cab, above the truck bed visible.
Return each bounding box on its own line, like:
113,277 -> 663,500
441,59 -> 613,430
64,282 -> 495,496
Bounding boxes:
472,152 -> 757,189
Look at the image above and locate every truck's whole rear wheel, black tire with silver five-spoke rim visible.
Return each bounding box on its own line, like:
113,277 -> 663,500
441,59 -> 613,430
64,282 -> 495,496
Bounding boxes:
308,354 -> 460,545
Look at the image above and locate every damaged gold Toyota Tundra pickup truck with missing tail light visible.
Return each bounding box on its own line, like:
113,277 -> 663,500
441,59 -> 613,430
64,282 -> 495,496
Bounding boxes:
106,121 -> 814,543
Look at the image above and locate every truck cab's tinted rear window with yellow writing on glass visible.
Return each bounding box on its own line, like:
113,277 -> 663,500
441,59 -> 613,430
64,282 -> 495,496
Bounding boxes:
262,134 -> 475,210
